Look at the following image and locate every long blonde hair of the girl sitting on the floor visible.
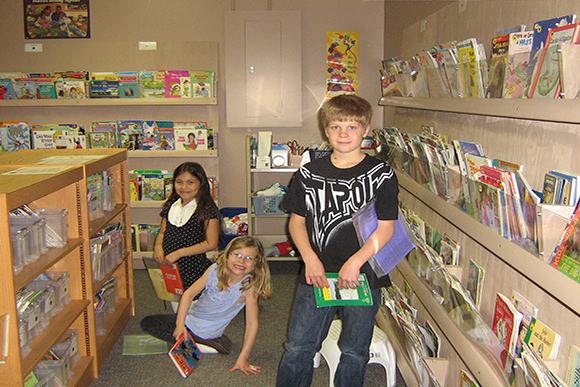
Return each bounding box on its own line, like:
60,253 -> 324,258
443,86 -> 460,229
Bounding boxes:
217,235 -> 272,298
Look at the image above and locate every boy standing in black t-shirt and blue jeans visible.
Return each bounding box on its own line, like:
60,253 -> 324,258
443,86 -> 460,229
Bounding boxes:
277,95 -> 399,387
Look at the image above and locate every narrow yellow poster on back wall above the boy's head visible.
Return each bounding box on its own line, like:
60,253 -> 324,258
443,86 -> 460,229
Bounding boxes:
326,31 -> 358,97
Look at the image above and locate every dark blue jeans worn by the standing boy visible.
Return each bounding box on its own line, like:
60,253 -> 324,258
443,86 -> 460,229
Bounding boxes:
276,284 -> 381,387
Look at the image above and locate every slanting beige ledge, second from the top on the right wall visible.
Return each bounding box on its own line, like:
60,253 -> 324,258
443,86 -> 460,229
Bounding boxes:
397,171 -> 580,315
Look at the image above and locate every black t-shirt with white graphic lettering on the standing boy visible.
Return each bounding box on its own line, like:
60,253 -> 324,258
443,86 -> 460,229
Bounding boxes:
283,155 -> 399,288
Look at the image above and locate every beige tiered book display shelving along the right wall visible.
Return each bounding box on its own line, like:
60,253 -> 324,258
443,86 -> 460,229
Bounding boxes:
377,97 -> 580,387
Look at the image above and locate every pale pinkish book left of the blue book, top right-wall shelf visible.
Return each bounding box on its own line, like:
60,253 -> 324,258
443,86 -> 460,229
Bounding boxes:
503,31 -> 534,98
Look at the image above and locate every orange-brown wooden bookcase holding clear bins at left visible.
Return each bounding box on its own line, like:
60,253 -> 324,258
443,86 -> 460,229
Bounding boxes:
0,149 -> 135,386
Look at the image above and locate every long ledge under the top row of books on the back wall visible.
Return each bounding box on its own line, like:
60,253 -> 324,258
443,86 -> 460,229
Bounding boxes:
0,97 -> 217,107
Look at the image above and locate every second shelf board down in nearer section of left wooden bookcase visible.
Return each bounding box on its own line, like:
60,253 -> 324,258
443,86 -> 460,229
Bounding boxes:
22,300 -> 89,378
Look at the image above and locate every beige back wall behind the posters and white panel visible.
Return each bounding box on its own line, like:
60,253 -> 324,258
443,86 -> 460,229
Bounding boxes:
0,0 -> 384,207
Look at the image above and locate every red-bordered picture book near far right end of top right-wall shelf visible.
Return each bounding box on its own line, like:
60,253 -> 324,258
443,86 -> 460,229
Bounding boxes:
528,23 -> 580,98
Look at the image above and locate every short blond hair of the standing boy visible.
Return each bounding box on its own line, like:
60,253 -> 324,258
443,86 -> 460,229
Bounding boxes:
318,94 -> 373,132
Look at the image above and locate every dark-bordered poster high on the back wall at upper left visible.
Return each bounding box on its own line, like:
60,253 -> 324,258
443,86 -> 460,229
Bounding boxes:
24,0 -> 91,39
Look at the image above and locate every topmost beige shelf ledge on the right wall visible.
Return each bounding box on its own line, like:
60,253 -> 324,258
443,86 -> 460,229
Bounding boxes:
379,97 -> 580,124
